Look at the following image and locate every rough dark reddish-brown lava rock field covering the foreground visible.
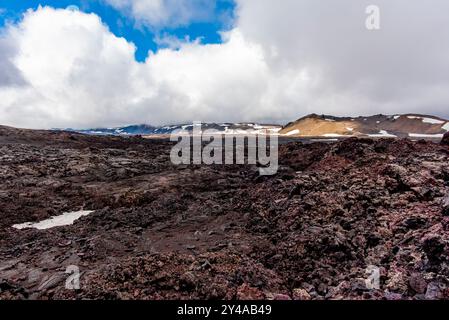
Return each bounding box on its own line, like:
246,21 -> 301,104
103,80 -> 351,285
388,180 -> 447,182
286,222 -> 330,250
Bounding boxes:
0,127 -> 449,299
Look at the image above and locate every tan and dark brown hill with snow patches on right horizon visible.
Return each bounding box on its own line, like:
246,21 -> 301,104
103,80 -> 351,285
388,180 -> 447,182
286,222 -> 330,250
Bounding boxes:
279,114 -> 449,139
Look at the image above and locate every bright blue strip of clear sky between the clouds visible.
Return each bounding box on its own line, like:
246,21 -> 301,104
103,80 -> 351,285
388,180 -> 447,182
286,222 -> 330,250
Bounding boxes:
0,0 -> 235,62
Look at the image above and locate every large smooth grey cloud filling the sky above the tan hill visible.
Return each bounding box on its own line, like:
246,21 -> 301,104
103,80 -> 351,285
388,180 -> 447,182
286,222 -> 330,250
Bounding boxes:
239,0 -> 449,116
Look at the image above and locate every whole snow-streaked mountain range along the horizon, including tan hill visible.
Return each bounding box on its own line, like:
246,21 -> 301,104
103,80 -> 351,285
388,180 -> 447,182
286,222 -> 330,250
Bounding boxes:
66,114 -> 449,139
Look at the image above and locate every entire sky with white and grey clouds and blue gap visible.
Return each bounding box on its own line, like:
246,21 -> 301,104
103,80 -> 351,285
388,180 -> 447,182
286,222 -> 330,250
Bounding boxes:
0,0 -> 449,128
